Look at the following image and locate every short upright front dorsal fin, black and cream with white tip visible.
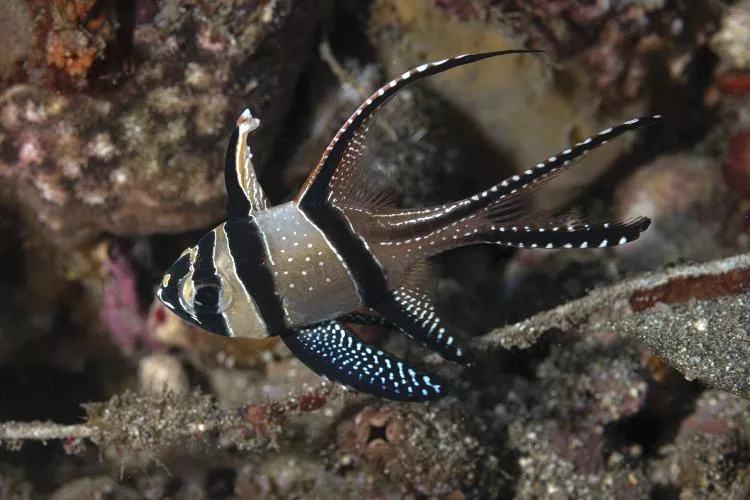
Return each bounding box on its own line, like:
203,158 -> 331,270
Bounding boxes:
224,109 -> 269,219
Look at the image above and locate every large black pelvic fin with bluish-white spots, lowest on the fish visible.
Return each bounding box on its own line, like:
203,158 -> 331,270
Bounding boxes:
281,320 -> 447,401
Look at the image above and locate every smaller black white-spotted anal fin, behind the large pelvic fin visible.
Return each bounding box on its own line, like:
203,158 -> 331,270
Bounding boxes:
375,286 -> 474,366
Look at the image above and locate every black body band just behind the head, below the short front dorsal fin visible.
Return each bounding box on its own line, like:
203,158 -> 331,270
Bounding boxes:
224,217 -> 288,335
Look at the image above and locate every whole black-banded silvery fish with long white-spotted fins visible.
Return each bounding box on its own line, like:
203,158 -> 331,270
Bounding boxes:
156,49 -> 661,402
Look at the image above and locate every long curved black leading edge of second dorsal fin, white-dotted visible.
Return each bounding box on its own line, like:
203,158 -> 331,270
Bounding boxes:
295,50 -> 540,207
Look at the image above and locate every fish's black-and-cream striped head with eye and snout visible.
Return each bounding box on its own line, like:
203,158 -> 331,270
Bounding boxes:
156,226 -> 242,337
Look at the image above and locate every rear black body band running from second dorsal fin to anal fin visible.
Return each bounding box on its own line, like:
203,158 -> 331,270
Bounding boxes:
300,202 -> 388,307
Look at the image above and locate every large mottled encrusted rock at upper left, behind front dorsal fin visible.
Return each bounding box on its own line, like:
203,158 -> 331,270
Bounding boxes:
0,0 -> 324,246
